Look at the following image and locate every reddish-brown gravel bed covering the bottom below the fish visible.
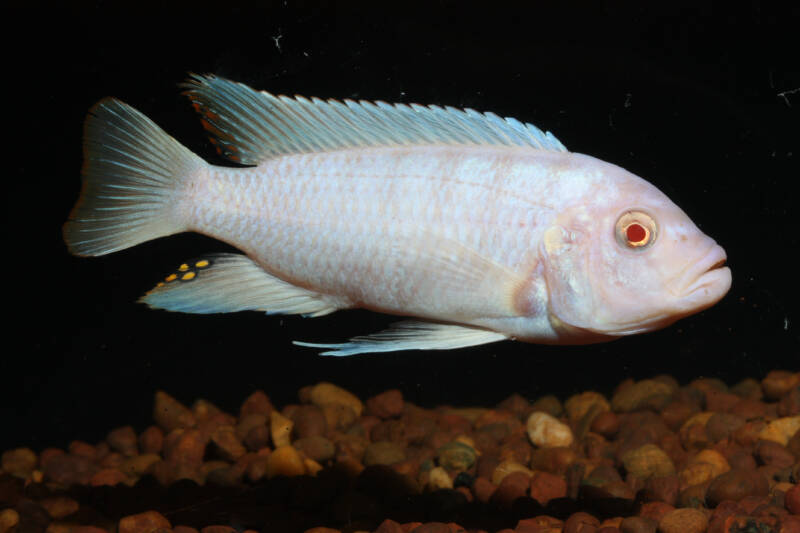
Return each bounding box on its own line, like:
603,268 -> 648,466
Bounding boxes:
0,371 -> 800,533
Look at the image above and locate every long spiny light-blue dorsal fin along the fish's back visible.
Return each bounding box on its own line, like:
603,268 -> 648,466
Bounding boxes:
184,74 -> 567,165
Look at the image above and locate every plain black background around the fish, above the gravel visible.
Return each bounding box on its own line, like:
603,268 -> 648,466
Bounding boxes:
0,1 -> 800,450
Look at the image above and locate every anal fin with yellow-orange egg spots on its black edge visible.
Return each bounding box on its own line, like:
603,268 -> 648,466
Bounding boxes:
139,254 -> 339,316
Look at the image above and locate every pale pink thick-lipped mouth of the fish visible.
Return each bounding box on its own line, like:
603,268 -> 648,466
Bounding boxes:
679,243 -> 731,313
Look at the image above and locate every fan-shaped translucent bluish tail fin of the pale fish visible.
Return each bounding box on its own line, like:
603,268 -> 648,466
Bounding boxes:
64,98 -> 206,256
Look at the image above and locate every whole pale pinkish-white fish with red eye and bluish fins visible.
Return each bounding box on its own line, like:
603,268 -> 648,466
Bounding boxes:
63,74 -> 731,356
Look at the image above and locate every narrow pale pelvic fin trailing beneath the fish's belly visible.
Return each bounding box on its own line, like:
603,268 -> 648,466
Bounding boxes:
294,321 -> 508,356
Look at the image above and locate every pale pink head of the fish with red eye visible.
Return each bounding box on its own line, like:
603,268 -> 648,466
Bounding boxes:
542,165 -> 731,342
